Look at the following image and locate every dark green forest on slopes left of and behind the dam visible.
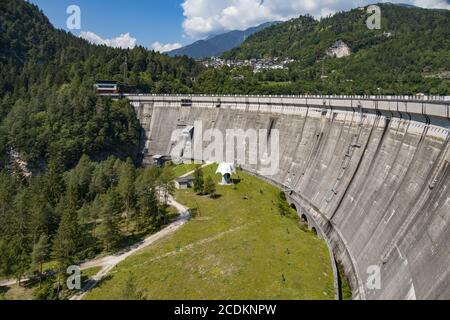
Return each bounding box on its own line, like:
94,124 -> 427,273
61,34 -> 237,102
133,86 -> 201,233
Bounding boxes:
0,0 -> 450,172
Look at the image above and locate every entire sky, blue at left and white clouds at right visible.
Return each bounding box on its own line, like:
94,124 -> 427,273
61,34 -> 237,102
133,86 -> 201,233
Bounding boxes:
29,0 -> 450,51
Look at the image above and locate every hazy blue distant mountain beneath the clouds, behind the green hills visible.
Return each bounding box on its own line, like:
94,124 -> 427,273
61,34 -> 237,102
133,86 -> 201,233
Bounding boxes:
167,21 -> 279,59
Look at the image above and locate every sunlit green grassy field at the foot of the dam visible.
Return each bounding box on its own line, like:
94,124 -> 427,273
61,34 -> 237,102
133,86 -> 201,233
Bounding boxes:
86,166 -> 334,299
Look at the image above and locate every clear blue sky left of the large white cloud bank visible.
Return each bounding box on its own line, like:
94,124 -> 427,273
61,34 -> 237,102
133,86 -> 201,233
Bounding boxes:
30,0 -> 186,48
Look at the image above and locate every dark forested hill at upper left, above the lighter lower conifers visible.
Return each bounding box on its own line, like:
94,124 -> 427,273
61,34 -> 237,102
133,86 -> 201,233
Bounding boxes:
0,0 -> 199,167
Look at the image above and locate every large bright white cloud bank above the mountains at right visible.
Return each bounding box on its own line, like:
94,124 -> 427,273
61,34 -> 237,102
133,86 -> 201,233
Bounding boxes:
182,0 -> 450,38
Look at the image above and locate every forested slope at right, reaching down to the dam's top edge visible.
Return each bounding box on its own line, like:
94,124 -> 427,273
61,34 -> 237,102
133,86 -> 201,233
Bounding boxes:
225,4 -> 450,94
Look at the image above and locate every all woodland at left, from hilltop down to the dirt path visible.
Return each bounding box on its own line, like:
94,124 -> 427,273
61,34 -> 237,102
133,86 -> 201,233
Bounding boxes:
0,0 -> 200,299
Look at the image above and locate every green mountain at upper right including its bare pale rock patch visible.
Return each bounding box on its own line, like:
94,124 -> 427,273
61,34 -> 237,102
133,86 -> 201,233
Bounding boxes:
223,3 -> 450,75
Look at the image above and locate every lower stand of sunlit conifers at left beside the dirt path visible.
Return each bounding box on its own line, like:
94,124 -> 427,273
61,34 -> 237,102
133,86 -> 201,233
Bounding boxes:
0,156 -> 174,298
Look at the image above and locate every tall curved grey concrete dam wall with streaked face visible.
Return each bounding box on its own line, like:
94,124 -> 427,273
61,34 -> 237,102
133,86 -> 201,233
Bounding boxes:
127,95 -> 450,299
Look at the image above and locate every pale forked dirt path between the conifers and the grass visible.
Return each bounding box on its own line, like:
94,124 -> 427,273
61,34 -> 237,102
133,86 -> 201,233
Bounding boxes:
70,196 -> 190,300
